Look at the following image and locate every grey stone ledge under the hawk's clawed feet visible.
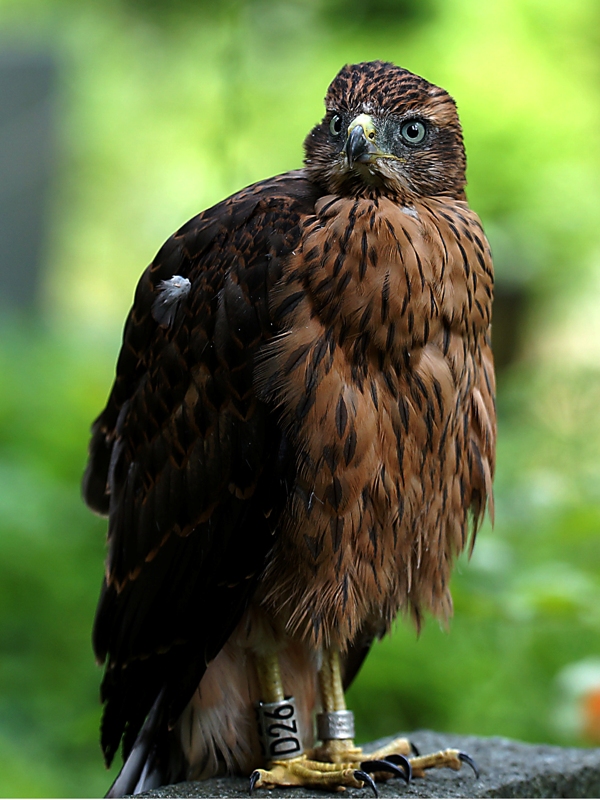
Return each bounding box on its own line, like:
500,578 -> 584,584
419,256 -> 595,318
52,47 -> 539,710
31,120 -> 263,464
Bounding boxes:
139,731 -> 600,800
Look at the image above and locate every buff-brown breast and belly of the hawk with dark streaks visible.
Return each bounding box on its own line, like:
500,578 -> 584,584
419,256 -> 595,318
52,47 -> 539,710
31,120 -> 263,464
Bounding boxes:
257,192 -> 491,644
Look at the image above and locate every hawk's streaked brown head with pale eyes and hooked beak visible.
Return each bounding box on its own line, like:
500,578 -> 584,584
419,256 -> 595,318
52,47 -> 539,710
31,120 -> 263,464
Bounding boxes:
304,61 -> 466,199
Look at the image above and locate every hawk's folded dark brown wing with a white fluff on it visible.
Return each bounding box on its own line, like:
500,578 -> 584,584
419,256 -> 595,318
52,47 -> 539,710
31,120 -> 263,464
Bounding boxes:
84,172 -> 315,762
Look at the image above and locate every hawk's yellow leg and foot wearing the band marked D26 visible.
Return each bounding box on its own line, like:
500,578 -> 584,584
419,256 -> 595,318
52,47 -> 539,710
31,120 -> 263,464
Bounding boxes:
250,653 -> 405,793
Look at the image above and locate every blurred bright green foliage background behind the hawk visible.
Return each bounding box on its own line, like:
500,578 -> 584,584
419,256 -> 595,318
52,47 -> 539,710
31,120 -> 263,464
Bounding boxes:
0,0 -> 600,797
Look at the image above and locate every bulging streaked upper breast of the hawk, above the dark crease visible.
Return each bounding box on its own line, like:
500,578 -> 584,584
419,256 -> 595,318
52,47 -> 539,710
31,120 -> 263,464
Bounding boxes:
280,192 -> 491,366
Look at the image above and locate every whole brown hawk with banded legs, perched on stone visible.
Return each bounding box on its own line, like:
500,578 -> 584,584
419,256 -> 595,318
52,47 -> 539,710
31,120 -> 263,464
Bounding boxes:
84,61 -> 495,796
